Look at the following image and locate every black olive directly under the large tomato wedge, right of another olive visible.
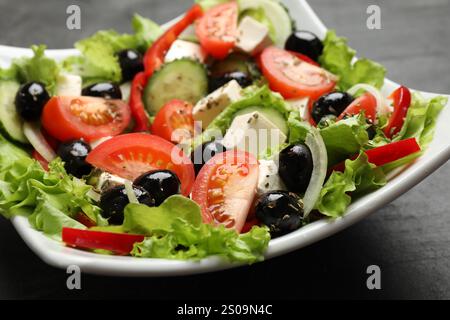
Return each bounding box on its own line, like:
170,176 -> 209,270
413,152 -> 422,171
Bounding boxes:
134,170 -> 181,206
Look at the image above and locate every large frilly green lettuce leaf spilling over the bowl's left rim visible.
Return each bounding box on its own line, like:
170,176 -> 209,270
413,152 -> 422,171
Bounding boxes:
0,143 -> 107,238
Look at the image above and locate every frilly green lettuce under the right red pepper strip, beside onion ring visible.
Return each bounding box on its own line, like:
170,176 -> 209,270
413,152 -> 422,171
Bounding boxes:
316,152 -> 386,218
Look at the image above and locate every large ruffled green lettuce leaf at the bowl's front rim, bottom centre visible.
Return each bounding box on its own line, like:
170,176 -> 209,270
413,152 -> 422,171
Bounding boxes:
122,195 -> 270,263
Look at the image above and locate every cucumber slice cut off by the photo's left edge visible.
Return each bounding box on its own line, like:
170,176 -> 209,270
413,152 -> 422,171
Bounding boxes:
0,81 -> 28,143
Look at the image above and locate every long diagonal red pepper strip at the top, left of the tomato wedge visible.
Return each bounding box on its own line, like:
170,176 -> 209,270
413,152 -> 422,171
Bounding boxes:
144,4 -> 203,78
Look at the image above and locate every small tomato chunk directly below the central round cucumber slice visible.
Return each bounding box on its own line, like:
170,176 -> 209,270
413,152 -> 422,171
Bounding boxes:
152,100 -> 194,143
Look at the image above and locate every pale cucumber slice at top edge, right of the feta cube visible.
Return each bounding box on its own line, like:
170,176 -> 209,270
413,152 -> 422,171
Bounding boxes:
238,0 -> 294,47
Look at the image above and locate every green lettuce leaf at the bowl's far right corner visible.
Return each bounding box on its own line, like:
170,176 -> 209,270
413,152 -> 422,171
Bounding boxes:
393,92 -> 448,149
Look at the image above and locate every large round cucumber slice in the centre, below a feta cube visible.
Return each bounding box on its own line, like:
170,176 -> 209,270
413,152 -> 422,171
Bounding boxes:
143,59 -> 208,115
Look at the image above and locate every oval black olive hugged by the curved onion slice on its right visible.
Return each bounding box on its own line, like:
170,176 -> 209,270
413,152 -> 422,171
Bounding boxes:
278,144 -> 313,193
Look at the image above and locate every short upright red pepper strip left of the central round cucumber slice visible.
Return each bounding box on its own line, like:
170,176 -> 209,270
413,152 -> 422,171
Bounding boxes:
130,72 -> 150,132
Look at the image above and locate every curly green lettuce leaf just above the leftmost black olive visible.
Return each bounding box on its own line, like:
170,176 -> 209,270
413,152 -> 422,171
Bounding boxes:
12,45 -> 59,92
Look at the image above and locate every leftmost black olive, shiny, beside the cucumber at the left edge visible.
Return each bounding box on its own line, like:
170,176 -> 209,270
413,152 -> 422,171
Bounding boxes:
15,82 -> 50,121
